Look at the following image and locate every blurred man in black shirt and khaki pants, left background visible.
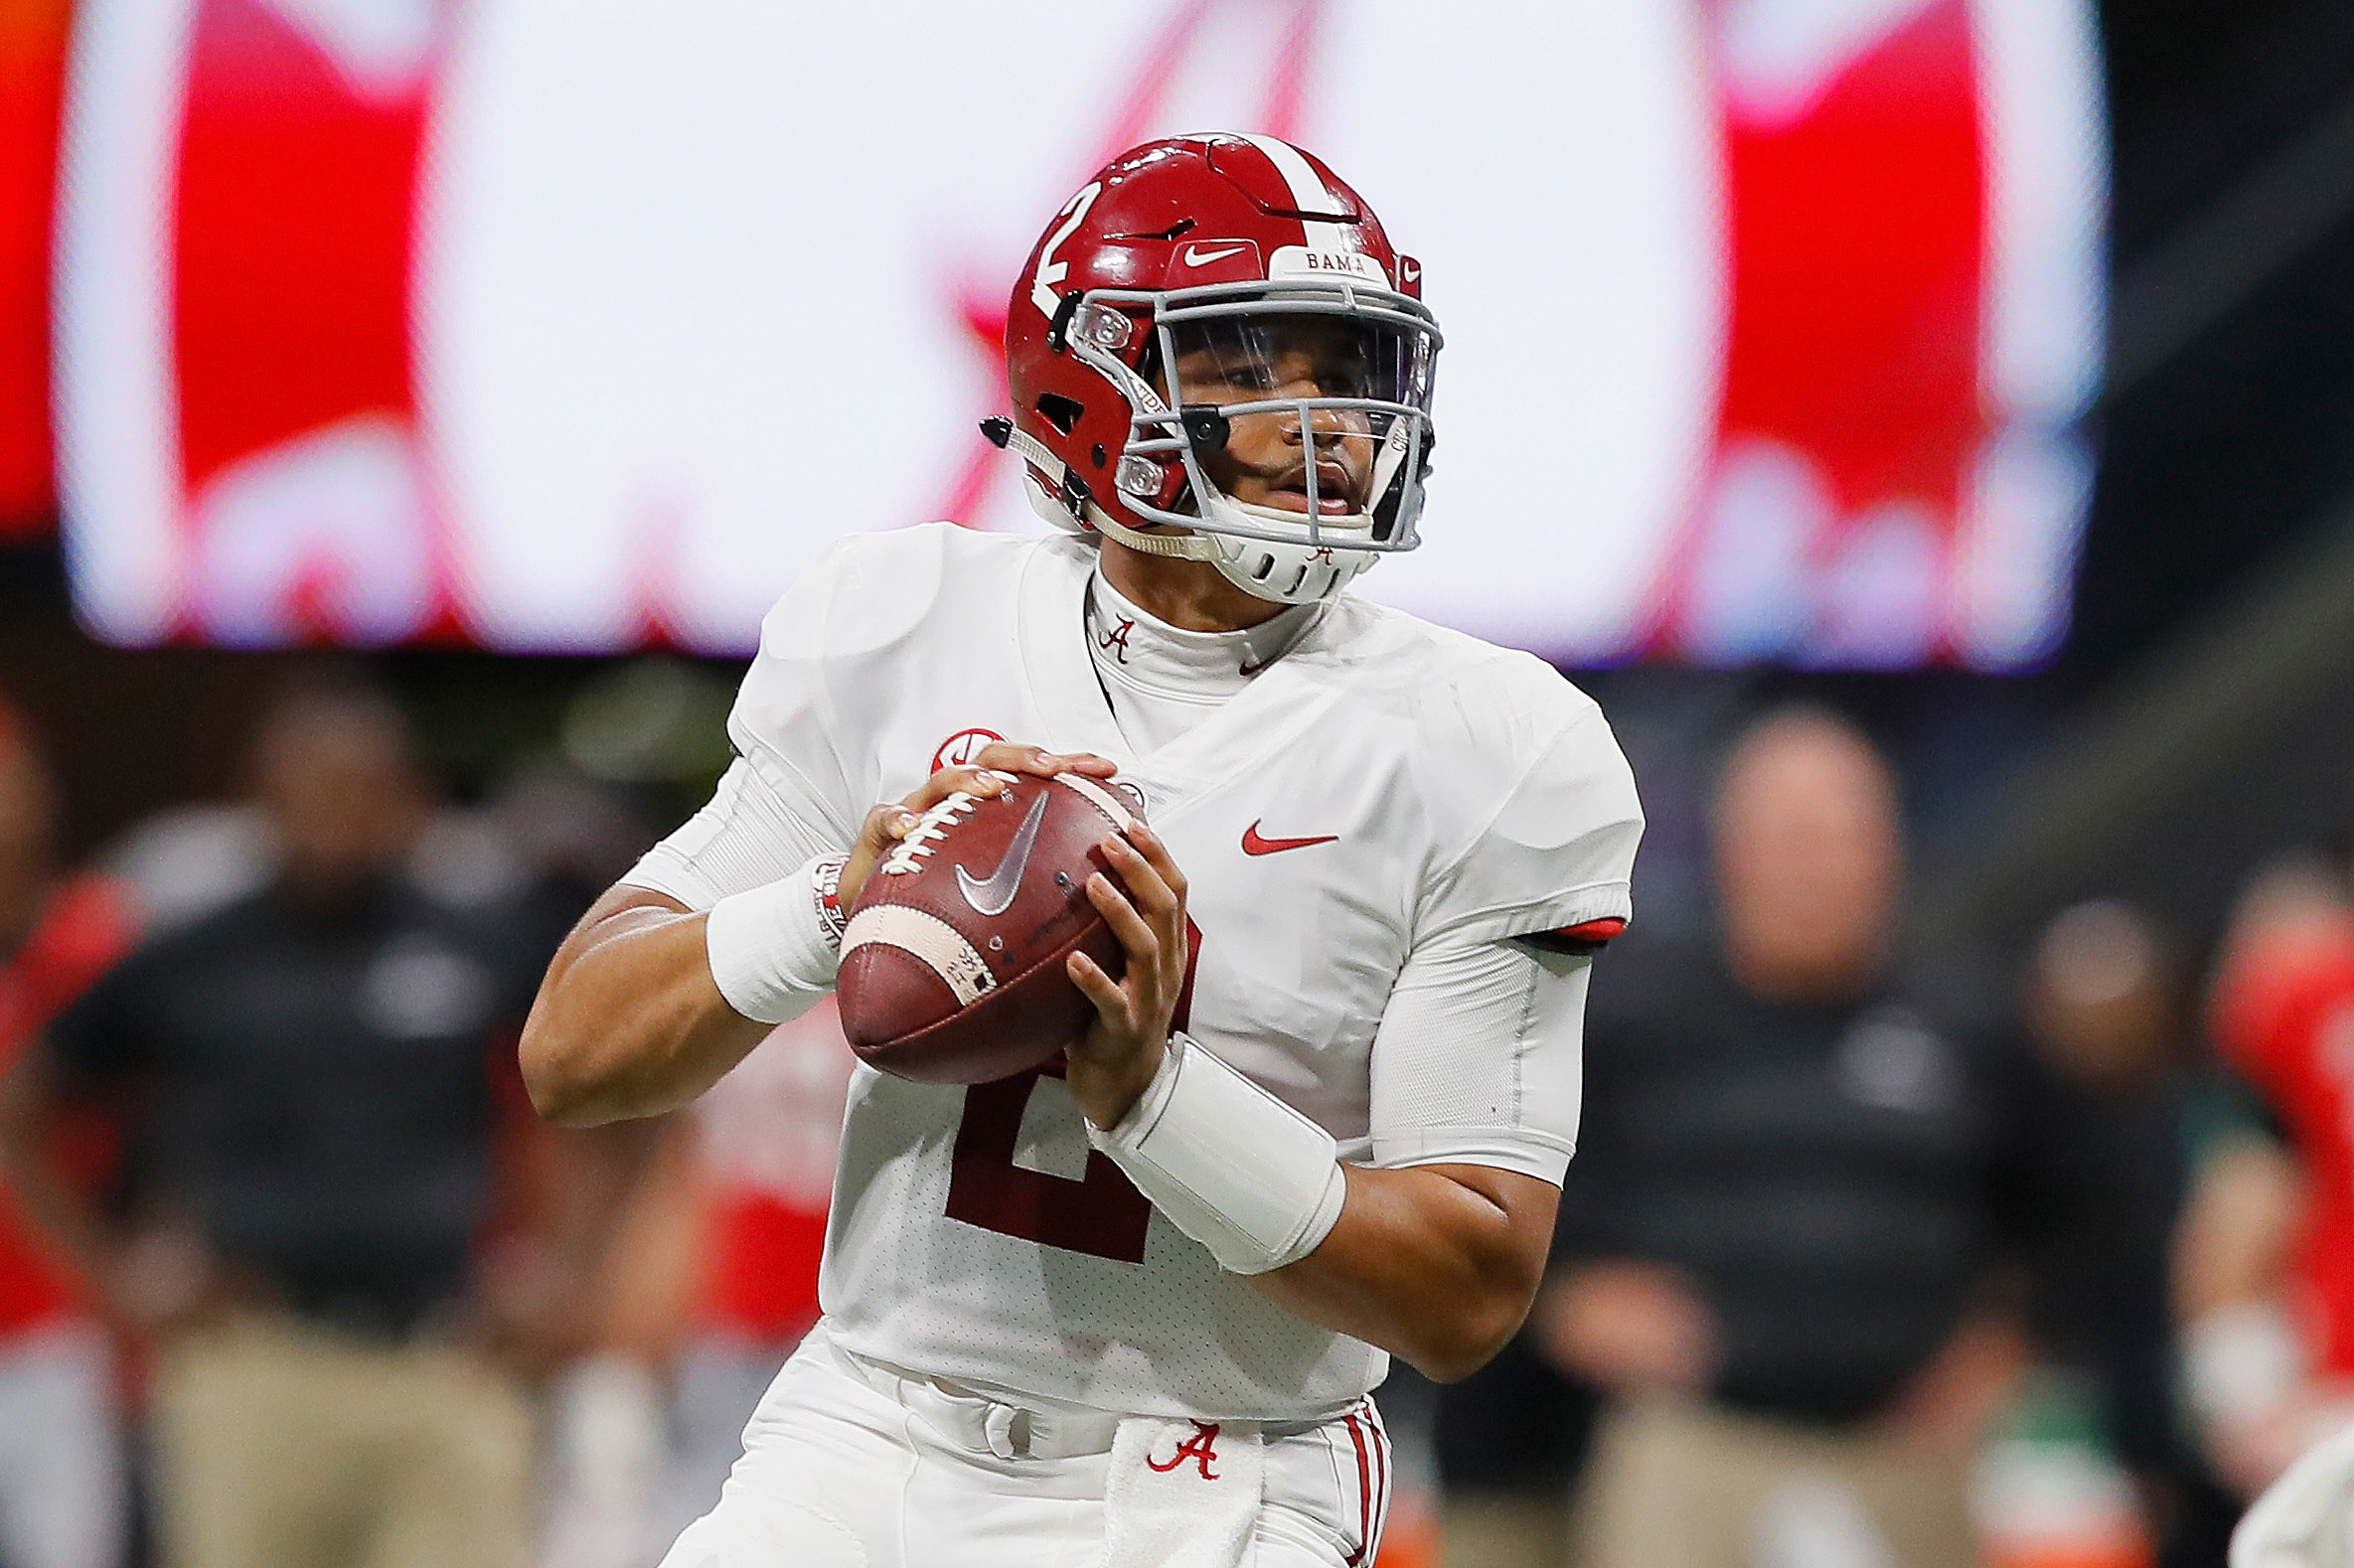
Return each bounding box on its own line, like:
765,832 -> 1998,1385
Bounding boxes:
9,688 -> 629,1568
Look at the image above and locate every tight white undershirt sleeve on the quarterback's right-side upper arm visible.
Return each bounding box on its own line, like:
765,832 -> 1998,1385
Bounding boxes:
1370,942 -> 1594,1186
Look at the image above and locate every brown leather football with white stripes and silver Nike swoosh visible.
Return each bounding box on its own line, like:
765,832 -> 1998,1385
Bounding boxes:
841,772 -> 1137,1083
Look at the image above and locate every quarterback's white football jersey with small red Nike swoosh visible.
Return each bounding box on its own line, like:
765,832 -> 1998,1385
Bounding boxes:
654,525 -> 1644,1420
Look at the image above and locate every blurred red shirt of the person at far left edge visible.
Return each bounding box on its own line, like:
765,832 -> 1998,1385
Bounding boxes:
0,875 -> 134,1337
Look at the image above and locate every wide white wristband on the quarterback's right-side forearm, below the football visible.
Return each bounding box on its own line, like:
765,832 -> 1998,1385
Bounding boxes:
1087,1033 -> 1348,1274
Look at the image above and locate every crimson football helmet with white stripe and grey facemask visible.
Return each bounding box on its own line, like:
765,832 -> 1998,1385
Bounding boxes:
982,132 -> 1441,605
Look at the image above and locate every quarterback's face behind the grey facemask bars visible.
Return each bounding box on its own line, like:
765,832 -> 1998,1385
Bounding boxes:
1177,315 -> 1382,516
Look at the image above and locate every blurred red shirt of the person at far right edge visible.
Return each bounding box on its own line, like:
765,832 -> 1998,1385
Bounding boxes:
2213,913 -> 2354,1377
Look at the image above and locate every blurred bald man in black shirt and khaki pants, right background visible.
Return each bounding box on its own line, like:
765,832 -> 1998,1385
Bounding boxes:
1469,708 -> 2100,1568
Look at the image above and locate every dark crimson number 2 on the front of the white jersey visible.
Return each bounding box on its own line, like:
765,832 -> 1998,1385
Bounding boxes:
949,916 -> 1200,1262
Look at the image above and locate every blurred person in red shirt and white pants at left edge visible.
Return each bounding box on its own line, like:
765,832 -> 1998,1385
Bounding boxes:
0,704 -> 132,1568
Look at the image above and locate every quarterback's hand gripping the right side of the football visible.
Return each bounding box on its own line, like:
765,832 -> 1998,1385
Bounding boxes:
1064,822 -> 1186,1128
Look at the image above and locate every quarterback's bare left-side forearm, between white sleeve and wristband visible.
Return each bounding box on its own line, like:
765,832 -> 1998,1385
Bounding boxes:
521,887 -> 767,1128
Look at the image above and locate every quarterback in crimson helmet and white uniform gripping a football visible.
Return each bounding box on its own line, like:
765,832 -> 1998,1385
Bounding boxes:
523,134 -> 1644,1568
